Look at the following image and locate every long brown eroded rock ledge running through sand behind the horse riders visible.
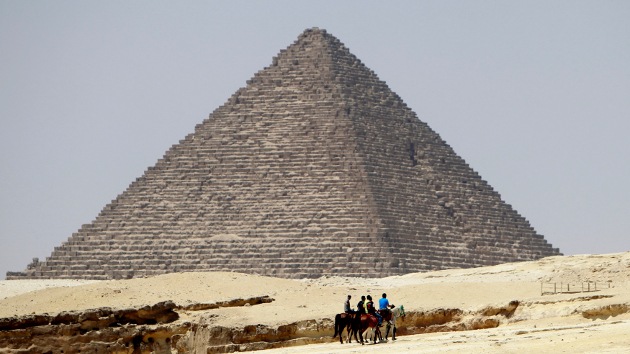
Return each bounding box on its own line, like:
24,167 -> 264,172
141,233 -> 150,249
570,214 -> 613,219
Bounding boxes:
0,297 -> 519,354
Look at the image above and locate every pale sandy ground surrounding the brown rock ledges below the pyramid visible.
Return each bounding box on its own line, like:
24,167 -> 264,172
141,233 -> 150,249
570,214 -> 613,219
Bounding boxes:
0,253 -> 630,353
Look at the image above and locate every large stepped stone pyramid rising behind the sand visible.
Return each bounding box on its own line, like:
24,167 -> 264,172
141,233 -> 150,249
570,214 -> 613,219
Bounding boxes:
7,28 -> 560,279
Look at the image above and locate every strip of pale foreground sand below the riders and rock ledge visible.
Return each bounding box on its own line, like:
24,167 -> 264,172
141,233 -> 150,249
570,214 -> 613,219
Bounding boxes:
238,317 -> 630,354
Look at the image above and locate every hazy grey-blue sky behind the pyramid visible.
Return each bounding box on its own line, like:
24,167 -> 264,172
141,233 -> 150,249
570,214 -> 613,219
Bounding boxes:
0,0 -> 630,279
